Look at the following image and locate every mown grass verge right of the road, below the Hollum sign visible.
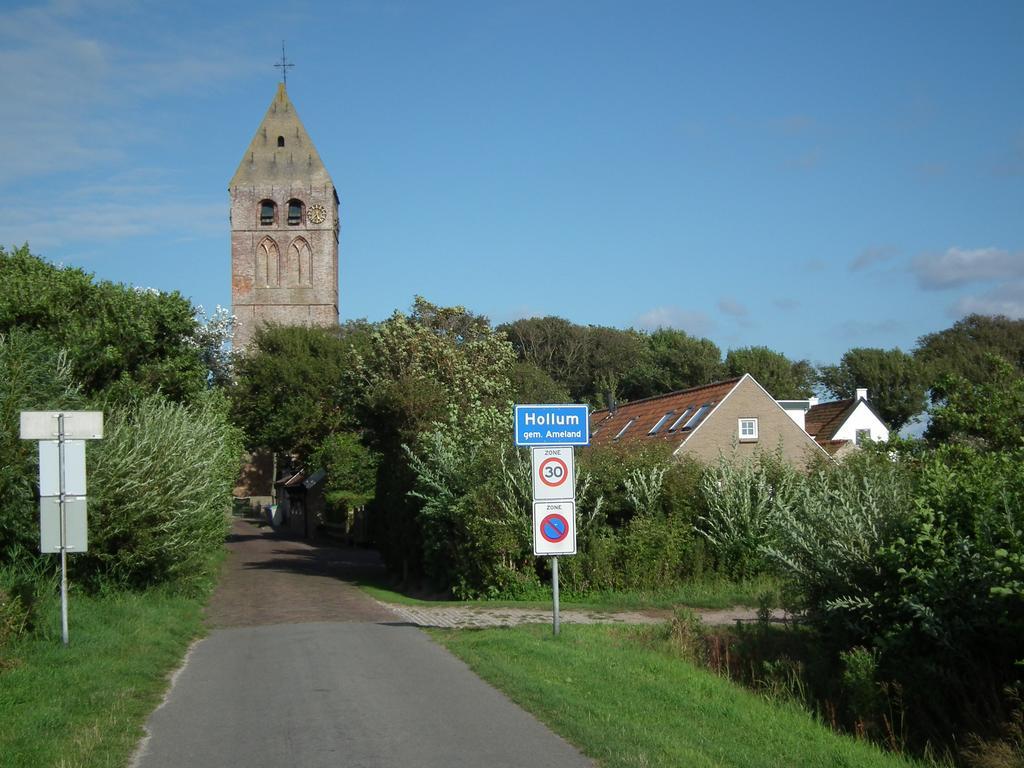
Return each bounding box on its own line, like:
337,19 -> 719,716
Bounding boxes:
431,626 -> 916,768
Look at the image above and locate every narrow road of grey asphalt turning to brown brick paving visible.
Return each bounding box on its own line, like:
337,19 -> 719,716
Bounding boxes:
133,520 -> 592,768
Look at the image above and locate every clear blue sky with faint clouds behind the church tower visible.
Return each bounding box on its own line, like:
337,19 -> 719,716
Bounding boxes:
0,0 -> 1024,364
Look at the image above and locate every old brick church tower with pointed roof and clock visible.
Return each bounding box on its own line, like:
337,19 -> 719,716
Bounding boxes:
228,83 -> 339,351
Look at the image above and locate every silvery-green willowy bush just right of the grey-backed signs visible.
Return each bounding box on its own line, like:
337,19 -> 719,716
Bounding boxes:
80,392 -> 242,587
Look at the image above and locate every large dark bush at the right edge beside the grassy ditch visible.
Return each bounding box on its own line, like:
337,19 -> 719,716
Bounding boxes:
768,445 -> 1024,761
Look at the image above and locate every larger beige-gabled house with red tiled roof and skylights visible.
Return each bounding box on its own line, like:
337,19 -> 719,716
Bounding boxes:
590,374 -> 828,468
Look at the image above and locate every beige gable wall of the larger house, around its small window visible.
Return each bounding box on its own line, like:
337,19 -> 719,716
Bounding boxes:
677,377 -> 825,469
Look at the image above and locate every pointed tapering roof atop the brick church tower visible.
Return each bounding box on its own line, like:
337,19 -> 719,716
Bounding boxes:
228,83 -> 334,186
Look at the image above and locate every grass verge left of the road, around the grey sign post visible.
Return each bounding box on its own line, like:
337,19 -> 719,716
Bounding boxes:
0,591 -> 204,768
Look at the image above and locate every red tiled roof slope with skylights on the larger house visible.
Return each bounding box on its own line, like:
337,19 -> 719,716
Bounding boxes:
590,379 -> 739,445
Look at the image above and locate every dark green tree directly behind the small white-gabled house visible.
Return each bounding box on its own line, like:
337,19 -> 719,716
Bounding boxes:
818,347 -> 928,431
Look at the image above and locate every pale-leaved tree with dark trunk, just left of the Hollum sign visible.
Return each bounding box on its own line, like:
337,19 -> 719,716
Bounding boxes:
351,297 -> 515,578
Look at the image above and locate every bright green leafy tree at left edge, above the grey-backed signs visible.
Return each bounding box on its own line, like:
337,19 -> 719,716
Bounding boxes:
0,246 -> 209,400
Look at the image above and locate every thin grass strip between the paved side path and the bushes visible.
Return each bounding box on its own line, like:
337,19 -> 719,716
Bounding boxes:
358,577 -> 779,611
